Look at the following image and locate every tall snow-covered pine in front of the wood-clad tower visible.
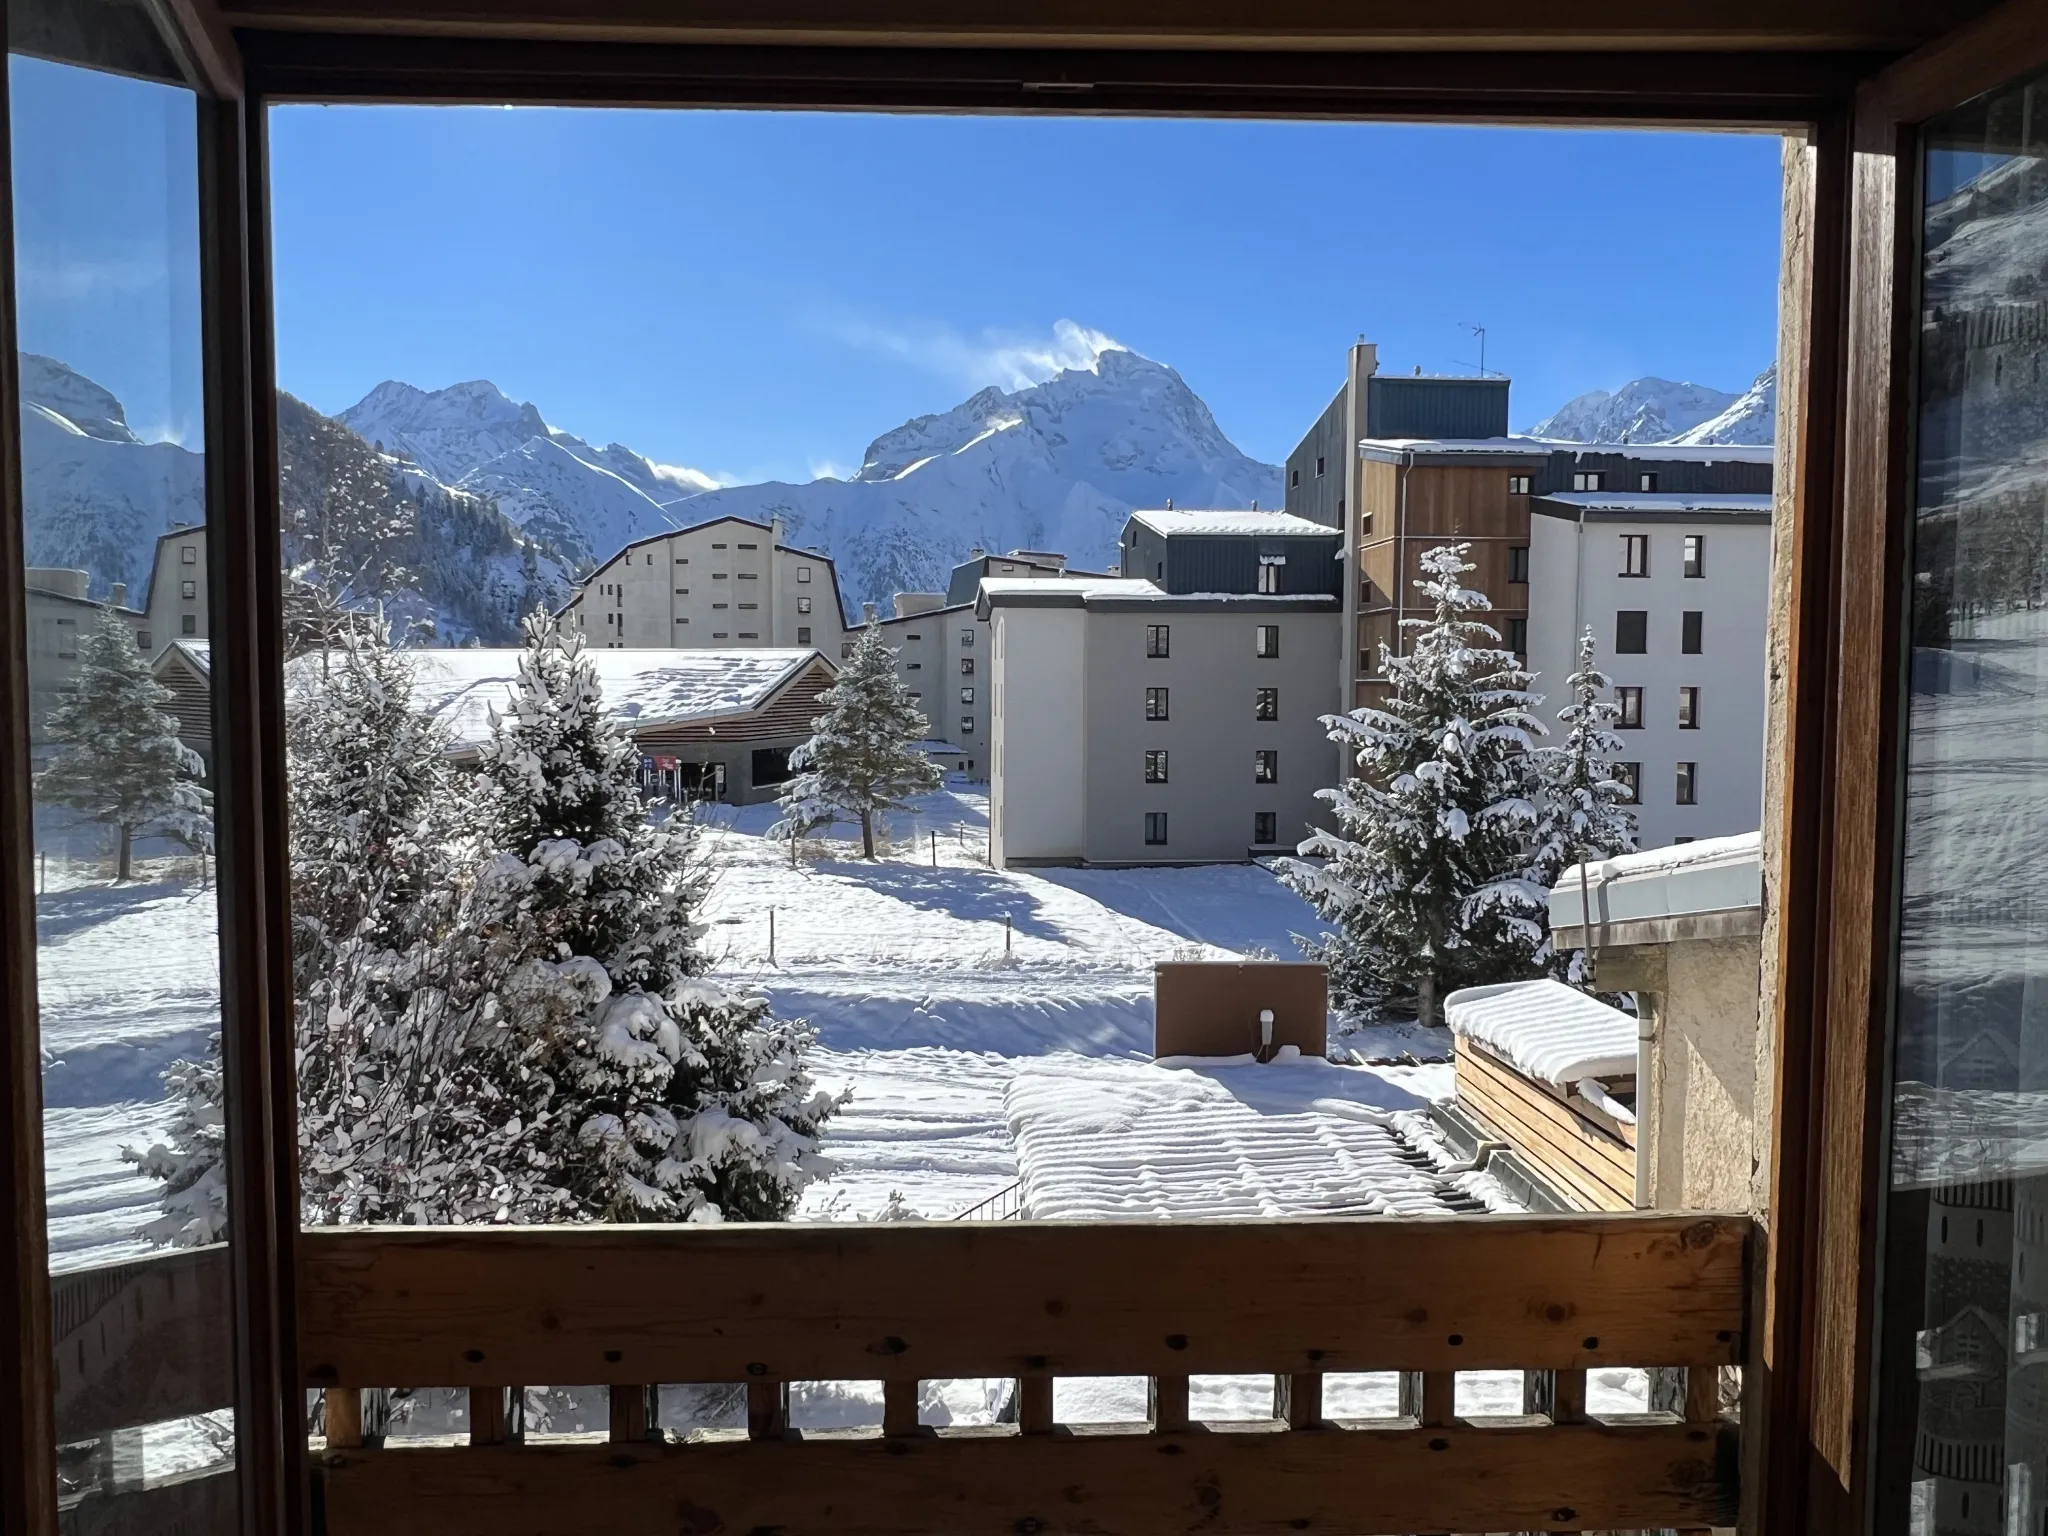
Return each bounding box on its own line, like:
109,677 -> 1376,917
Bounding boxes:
1280,545 -> 1546,1024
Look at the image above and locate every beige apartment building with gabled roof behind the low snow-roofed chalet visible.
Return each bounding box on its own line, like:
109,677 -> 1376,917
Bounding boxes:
559,518 -> 850,655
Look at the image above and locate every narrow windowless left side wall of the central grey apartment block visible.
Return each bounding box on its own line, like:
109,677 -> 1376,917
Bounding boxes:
989,606 -> 1087,868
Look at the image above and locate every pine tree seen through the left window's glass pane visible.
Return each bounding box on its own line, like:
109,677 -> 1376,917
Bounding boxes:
35,608 -> 213,883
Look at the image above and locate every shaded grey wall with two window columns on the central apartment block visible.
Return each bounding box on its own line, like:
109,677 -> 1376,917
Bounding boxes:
1075,604 -> 1339,864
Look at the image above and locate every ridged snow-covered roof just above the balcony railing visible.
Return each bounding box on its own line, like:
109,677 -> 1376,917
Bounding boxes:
1004,1047 -> 1482,1221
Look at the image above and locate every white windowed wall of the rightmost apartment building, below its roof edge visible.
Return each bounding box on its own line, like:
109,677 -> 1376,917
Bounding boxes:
1530,516 -> 1772,848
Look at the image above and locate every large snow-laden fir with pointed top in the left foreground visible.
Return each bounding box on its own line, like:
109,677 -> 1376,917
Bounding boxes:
461,612 -> 836,1221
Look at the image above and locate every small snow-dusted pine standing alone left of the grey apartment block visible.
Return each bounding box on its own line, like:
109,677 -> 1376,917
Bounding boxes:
782,625 -> 944,858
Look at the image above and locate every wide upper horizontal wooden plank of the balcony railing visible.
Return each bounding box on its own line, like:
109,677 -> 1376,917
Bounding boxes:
299,1212 -> 1749,1386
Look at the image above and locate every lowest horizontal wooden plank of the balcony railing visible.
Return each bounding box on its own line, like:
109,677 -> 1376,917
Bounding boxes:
313,1423 -> 1735,1536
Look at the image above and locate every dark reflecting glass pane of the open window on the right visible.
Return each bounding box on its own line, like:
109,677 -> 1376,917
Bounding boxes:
1878,60 -> 2048,1534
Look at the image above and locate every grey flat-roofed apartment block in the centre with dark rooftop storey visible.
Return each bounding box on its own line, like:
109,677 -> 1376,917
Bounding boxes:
977,512 -> 1341,868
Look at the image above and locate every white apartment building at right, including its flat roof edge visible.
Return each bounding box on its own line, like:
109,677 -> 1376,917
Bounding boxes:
1528,492 -> 1772,848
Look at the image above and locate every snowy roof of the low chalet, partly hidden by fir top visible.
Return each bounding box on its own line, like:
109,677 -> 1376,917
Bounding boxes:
331,647 -> 829,748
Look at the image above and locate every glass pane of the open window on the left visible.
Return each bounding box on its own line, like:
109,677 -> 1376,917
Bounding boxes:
8,4 -> 233,1530
